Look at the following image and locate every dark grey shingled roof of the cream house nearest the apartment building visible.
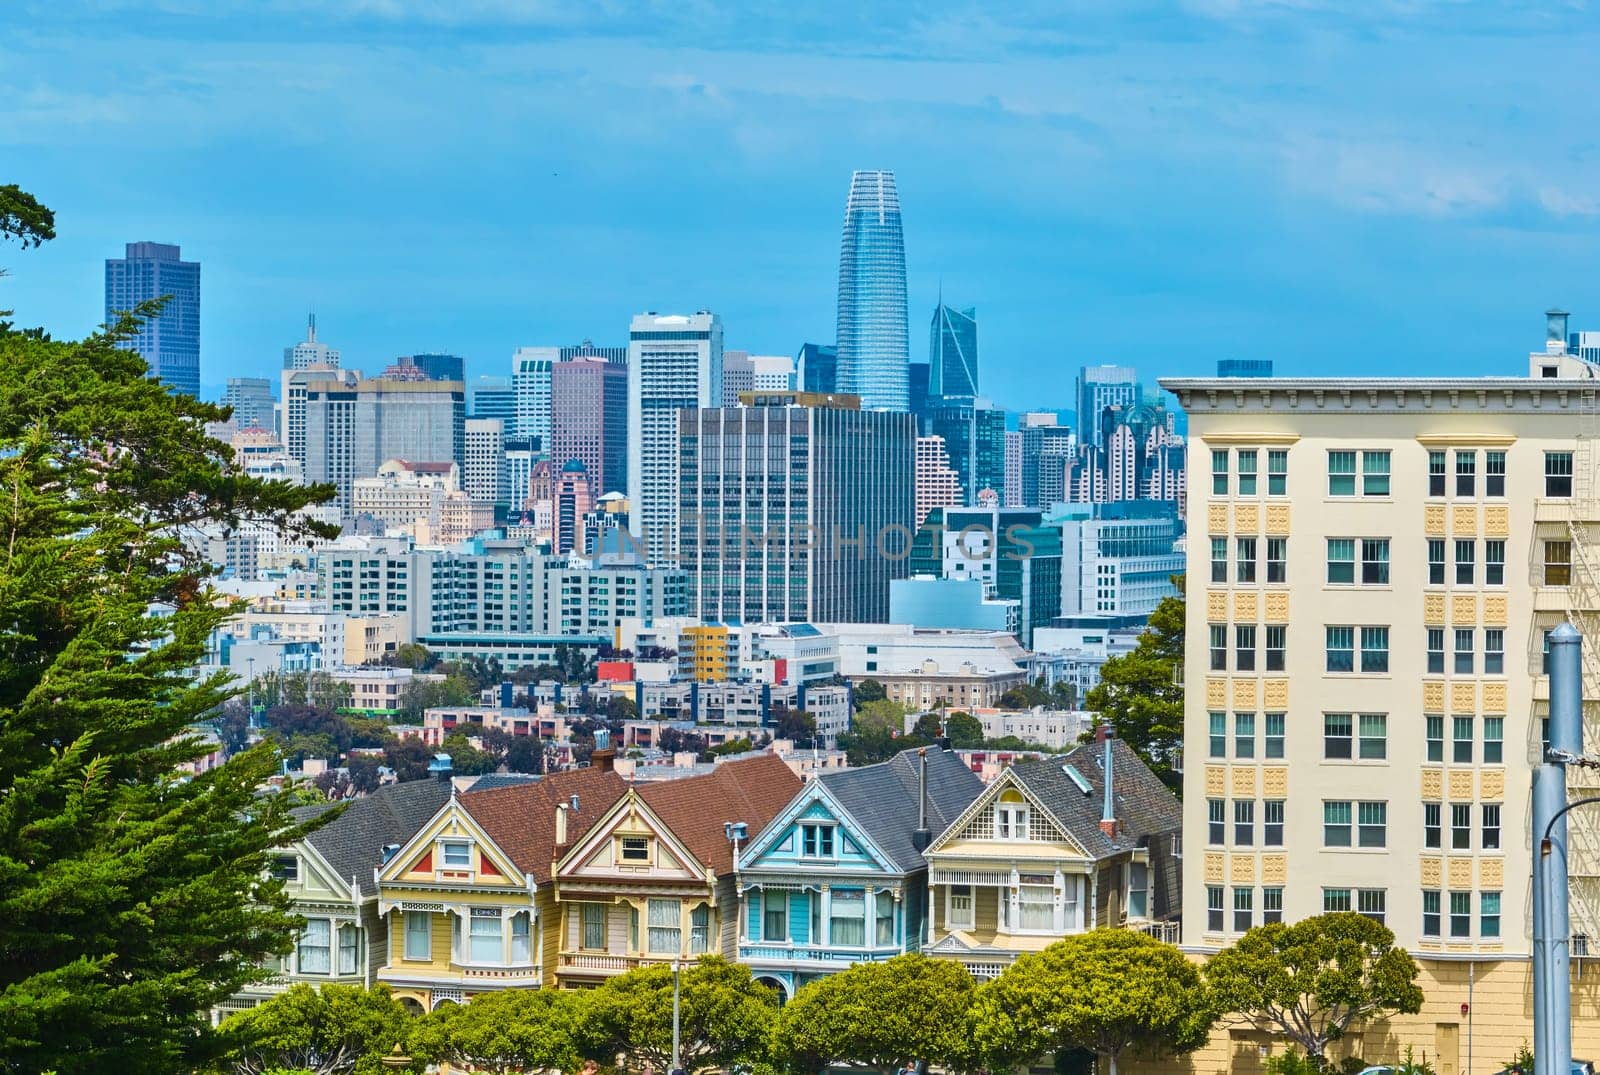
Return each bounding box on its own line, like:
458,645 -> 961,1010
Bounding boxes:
1011,739 -> 1182,859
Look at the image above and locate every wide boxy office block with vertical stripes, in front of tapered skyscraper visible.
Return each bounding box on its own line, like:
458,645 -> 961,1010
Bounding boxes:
678,394 -> 915,622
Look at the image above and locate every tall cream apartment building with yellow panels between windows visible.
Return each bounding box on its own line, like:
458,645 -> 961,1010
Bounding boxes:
1162,342 -> 1600,1075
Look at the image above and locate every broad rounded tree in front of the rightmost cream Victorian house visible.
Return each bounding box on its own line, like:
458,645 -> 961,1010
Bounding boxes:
971,929 -> 1216,1075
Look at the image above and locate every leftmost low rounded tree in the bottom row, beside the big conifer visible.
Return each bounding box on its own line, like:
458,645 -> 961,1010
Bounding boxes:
221,984 -> 411,1075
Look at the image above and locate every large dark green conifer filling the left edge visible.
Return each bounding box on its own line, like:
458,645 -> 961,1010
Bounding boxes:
0,289 -> 331,1075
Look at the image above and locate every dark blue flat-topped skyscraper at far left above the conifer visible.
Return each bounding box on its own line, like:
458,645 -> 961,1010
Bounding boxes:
106,243 -> 200,395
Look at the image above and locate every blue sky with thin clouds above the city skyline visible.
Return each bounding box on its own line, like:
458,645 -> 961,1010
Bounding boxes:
0,0 -> 1600,408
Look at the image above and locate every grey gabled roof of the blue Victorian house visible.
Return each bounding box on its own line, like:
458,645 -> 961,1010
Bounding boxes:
818,750 -> 984,872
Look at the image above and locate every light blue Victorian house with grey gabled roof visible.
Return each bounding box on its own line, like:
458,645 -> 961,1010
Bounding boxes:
738,749 -> 984,1000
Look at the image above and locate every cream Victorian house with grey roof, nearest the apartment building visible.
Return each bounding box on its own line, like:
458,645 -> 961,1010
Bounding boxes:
925,737 -> 1182,977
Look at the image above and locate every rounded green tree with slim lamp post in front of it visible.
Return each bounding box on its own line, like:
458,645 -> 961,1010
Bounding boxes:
582,955 -> 778,1072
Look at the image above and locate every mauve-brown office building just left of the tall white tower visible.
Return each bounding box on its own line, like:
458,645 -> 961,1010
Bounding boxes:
550,358 -> 627,496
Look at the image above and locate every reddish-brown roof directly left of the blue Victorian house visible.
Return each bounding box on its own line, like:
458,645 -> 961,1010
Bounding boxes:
638,753 -> 800,875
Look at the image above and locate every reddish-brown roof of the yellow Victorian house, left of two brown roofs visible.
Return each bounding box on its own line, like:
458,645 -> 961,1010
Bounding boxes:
461,769 -> 627,885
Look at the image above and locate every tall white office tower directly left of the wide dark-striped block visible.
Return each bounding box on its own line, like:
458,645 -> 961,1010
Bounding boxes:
624,310 -> 722,563
